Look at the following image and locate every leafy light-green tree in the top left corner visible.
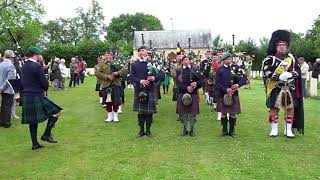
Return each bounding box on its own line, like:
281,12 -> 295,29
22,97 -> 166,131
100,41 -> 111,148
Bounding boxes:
0,0 -> 45,51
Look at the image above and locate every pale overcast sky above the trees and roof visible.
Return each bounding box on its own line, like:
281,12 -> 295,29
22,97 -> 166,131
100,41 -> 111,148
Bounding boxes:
41,0 -> 320,44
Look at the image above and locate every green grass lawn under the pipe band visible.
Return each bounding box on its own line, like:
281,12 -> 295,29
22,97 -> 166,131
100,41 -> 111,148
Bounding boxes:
0,78 -> 320,179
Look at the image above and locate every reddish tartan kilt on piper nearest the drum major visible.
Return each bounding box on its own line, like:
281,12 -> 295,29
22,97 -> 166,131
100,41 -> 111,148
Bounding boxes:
216,95 -> 241,114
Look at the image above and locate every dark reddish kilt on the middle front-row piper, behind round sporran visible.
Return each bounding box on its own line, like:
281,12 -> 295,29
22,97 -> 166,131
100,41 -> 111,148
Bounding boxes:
176,93 -> 200,114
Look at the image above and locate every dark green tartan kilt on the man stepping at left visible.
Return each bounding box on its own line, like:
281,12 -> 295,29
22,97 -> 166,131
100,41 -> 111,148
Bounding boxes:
21,96 -> 62,124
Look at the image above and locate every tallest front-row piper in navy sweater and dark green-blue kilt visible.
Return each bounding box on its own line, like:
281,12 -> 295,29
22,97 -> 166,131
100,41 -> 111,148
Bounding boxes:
130,46 -> 164,137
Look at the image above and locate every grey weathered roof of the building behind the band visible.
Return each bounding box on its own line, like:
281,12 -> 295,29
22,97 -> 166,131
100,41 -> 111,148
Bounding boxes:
133,29 -> 212,49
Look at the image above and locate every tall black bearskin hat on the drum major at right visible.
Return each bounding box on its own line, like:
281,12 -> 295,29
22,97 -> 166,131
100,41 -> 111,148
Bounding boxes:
267,30 -> 291,55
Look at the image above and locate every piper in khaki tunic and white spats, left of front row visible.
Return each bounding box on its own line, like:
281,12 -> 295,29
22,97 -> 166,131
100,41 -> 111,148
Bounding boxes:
95,50 -> 127,122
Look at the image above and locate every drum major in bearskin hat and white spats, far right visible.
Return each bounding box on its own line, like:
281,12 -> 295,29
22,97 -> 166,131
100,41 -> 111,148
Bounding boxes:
262,30 -> 304,138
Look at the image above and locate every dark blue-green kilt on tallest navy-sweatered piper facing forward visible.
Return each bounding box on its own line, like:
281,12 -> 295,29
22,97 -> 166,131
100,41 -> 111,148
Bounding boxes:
133,85 -> 158,114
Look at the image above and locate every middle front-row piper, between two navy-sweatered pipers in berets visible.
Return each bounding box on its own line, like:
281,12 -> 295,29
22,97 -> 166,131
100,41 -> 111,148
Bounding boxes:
176,55 -> 205,136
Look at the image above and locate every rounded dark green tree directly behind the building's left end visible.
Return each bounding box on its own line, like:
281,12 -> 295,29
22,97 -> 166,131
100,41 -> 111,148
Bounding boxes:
106,13 -> 163,43
